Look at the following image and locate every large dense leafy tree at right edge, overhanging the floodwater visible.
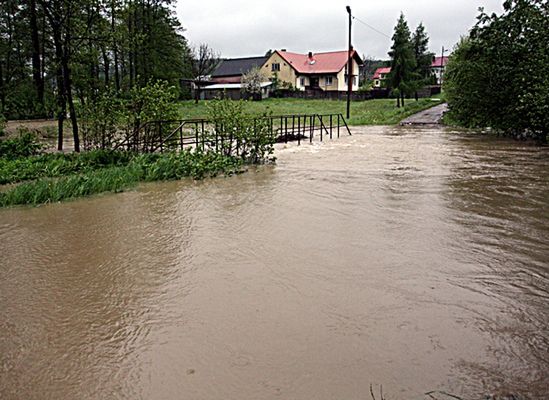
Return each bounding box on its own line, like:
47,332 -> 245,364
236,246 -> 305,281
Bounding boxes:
445,0 -> 549,142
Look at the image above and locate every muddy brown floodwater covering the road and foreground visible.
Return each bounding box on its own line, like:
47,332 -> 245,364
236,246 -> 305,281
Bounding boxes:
0,127 -> 549,400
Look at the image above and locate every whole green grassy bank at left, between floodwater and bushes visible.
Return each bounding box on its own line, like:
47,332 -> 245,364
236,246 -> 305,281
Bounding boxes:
0,151 -> 242,207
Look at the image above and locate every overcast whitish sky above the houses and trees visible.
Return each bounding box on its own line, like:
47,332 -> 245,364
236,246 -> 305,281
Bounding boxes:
176,0 -> 503,59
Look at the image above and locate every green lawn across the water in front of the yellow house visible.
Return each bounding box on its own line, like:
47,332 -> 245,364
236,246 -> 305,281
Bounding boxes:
179,99 -> 440,125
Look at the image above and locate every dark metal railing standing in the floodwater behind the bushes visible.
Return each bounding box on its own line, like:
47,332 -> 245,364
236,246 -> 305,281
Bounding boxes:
114,114 -> 351,153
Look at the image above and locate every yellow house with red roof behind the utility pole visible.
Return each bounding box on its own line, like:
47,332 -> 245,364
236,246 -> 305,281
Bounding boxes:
261,50 -> 362,92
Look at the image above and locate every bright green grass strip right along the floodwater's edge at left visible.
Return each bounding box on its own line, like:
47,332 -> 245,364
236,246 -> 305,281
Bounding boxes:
0,151 -> 242,207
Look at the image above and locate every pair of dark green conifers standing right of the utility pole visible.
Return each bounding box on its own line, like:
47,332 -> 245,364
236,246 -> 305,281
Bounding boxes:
387,13 -> 434,107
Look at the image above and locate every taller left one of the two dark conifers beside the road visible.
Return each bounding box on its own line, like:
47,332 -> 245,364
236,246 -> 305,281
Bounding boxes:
389,13 -> 416,107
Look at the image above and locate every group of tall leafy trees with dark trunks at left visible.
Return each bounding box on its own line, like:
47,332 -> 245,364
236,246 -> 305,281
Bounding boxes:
0,0 -> 213,151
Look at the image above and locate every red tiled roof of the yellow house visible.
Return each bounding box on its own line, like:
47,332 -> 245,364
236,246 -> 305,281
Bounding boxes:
277,50 -> 360,74
